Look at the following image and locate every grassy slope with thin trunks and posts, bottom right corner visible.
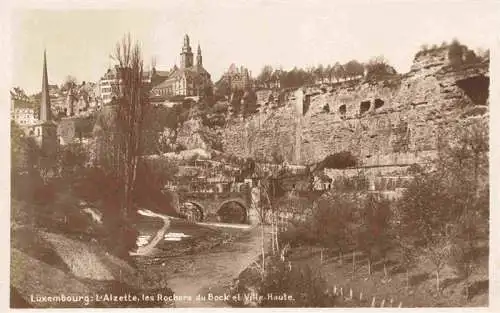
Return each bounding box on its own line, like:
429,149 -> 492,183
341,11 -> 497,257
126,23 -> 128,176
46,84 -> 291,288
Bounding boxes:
290,243 -> 488,307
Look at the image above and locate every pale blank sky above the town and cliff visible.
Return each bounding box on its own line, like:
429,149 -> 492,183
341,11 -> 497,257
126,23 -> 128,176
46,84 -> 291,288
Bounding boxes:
11,0 -> 500,93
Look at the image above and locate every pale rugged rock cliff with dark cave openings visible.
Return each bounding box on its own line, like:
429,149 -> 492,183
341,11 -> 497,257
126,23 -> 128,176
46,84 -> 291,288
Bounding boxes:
222,48 -> 489,166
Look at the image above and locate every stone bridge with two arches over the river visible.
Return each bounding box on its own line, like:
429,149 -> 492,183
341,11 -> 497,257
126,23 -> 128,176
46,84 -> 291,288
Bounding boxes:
177,191 -> 255,223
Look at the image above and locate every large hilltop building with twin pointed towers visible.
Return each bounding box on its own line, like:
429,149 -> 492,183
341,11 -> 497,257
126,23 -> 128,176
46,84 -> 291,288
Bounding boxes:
148,35 -> 212,97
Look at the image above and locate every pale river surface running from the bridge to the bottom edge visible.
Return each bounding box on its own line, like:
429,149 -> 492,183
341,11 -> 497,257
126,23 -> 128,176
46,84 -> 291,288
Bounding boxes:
168,227 -> 269,307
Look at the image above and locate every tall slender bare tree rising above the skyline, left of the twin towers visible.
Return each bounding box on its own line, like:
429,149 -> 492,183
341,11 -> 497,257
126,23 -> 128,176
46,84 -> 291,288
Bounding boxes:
109,34 -> 148,219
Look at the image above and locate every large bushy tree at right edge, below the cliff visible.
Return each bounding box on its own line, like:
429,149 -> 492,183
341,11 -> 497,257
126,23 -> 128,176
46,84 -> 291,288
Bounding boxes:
397,119 -> 489,293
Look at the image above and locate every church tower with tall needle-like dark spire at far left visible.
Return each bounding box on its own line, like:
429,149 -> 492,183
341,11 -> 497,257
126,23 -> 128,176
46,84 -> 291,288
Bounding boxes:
31,51 -> 59,157
